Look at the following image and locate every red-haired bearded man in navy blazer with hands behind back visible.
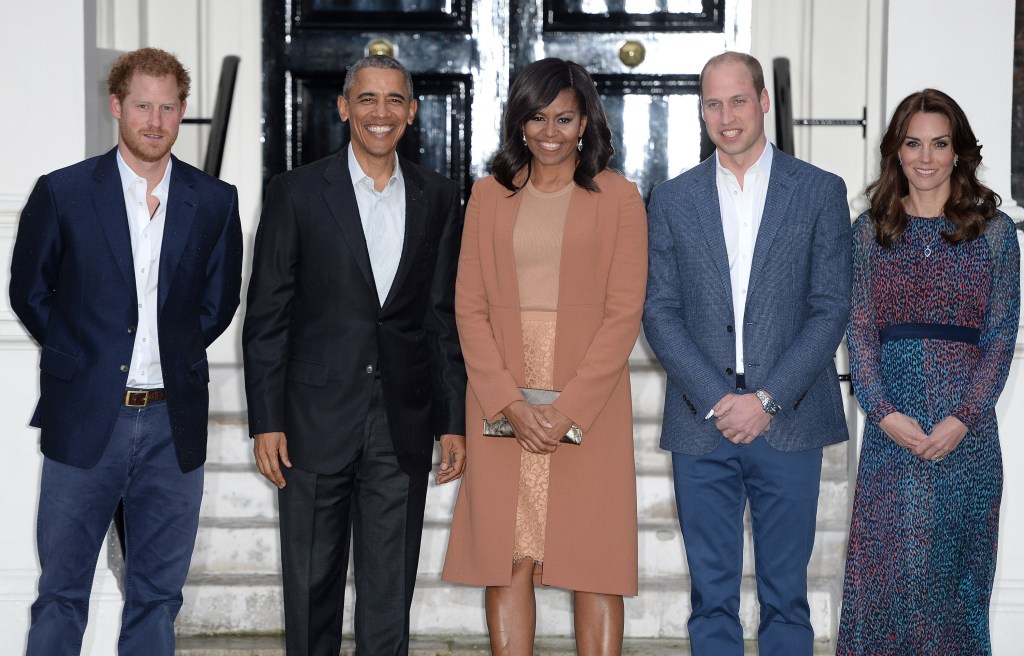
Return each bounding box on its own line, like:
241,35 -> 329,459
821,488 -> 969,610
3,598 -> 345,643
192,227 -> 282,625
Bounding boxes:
10,48 -> 242,656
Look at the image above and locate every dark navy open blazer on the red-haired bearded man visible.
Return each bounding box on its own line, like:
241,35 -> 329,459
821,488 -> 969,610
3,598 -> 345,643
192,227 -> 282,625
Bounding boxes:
10,148 -> 242,472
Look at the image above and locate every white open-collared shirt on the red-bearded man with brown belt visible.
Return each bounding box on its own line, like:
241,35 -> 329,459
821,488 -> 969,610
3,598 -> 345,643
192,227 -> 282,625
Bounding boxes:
118,150 -> 172,389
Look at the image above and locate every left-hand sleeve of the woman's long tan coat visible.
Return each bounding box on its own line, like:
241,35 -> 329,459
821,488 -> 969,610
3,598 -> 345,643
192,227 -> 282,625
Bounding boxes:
455,179 -> 522,420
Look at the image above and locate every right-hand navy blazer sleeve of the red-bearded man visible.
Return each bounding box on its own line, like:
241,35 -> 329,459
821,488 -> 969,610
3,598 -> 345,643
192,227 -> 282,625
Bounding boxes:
200,186 -> 242,346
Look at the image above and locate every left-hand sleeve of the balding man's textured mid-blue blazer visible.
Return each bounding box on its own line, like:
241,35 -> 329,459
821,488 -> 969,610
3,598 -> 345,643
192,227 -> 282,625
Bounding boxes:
643,182 -> 735,417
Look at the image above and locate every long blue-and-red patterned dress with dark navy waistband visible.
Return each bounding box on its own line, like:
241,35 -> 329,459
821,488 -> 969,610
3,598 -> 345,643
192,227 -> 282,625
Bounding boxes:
837,212 -> 1020,656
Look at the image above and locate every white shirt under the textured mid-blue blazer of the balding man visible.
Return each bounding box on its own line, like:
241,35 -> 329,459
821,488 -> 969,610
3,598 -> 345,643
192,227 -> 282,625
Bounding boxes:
715,142 -> 772,374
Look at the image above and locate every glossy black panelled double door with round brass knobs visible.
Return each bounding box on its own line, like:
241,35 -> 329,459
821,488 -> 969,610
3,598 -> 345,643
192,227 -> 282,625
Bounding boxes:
263,0 -> 750,198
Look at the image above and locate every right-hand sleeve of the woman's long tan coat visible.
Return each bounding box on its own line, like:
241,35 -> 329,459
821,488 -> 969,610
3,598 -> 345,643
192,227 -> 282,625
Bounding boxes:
554,183 -> 647,431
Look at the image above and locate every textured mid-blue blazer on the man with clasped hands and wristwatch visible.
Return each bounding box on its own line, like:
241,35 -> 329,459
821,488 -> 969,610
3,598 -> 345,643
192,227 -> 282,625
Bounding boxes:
643,146 -> 852,455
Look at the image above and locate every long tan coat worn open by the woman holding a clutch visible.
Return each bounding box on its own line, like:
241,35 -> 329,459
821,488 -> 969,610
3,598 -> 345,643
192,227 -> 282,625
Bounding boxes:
441,171 -> 647,595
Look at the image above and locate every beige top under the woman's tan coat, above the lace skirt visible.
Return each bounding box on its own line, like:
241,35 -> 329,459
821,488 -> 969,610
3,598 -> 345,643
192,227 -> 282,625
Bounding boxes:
512,180 -> 575,311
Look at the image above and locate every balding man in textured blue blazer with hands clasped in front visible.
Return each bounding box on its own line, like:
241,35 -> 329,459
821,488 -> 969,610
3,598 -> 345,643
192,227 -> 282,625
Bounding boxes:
644,52 -> 851,656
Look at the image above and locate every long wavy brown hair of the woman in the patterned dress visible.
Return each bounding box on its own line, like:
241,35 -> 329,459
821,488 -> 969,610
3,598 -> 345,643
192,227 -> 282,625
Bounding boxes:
866,89 -> 1001,248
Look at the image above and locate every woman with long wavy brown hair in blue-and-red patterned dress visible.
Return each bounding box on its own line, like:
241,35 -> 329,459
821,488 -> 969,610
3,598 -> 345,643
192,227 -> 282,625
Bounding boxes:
838,89 -> 1020,656
